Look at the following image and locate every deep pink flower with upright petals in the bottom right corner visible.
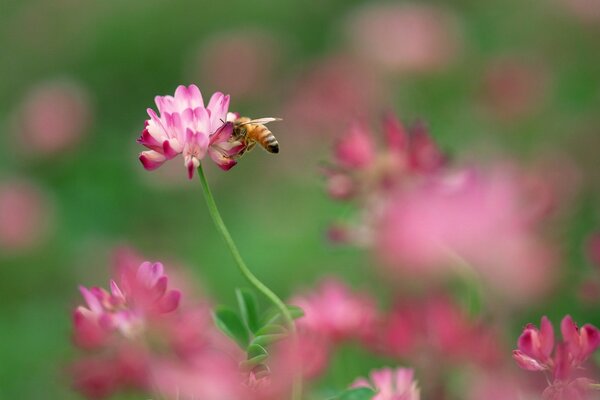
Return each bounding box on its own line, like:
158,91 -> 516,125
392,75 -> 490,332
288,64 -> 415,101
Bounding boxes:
513,315 -> 600,383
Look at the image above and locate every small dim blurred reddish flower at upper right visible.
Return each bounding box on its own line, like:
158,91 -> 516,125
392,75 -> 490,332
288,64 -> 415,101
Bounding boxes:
482,56 -> 550,120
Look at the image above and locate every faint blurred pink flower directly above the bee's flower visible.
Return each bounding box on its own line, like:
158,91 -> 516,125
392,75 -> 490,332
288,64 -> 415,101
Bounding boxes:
189,29 -> 279,101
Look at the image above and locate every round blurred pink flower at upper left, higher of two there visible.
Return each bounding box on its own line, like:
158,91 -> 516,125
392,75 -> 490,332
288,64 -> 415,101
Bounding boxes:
14,81 -> 92,156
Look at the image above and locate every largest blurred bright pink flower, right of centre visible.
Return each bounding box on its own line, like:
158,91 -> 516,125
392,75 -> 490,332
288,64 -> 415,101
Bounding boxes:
374,168 -> 552,300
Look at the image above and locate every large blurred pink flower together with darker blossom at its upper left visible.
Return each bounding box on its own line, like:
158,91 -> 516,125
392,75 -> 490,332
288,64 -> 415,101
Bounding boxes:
325,115 -> 553,301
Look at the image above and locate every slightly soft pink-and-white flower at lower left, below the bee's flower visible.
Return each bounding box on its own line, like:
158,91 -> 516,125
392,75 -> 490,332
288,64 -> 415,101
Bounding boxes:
73,262 -> 181,347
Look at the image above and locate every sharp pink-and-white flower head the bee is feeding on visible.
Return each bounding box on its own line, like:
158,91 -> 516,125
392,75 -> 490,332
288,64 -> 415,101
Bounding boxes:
138,85 -> 243,179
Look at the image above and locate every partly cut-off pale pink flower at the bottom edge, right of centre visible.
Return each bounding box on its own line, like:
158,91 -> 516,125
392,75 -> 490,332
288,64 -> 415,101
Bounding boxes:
352,368 -> 421,400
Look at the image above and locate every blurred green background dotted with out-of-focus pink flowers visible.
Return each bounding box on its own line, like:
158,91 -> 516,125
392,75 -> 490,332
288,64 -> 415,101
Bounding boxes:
0,0 -> 600,399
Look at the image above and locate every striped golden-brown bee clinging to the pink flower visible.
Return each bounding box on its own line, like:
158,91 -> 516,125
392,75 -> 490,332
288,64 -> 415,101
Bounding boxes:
233,117 -> 281,156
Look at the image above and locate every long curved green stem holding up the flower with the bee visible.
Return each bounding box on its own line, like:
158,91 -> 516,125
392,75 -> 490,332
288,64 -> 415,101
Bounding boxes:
198,164 -> 302,400
